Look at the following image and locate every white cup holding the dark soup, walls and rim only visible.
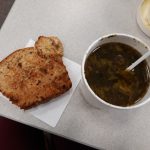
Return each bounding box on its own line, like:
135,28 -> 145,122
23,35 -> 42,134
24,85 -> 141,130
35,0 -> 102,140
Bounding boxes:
81,33 -> 150,110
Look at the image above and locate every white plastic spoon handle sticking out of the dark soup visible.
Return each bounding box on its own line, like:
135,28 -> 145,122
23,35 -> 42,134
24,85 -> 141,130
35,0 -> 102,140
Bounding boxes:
127,50 -> 150,71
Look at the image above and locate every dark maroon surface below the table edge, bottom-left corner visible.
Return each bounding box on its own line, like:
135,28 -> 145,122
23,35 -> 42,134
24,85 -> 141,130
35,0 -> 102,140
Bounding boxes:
0,117 -> 45,150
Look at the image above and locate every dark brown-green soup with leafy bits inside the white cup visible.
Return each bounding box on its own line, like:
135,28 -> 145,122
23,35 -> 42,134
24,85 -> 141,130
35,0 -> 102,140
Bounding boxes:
85,43 -> 149,107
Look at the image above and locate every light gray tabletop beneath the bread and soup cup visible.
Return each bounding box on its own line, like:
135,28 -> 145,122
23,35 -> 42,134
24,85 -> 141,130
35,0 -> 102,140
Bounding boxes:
0,0 -> 150,150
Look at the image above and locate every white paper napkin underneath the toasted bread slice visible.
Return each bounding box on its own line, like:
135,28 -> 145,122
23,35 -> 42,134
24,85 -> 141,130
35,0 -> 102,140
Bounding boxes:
26,39 -> 81,127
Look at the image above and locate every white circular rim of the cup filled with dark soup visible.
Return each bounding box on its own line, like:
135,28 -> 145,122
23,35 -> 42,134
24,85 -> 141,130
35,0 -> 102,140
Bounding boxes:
81,33 -> 150,110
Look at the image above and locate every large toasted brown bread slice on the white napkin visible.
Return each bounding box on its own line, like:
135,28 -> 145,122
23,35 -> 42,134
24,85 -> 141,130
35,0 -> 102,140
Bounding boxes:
0,37 -> 72,109
